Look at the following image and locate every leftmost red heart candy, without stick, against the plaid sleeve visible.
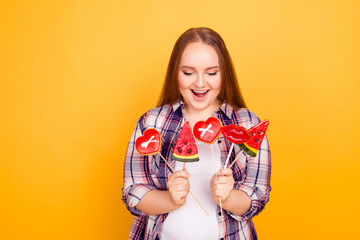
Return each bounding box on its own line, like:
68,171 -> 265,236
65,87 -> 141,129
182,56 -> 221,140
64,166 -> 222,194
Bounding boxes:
135,128 -> 161,155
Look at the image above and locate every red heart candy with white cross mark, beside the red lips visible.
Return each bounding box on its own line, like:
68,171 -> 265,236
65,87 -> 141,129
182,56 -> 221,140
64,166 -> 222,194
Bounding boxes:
194,117 -> 222,144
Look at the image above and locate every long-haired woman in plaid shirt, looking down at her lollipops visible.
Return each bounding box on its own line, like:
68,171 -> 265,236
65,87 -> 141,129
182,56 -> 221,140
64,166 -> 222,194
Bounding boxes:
122,28 -> 271,240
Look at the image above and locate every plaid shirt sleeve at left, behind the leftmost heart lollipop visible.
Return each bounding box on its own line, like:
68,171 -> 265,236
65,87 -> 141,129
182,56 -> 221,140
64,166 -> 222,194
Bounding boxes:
122,114 -> 156,216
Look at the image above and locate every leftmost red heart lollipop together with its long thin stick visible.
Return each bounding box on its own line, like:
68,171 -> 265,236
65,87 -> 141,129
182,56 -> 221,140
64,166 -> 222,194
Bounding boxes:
135,128 -> 209,216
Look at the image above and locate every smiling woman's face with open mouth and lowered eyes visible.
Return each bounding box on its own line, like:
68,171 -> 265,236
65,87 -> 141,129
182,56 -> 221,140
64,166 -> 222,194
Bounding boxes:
178,42 -> 221,114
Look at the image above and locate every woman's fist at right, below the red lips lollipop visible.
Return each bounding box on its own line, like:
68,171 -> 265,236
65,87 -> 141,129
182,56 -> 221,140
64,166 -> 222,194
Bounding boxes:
210,168 -> 235,205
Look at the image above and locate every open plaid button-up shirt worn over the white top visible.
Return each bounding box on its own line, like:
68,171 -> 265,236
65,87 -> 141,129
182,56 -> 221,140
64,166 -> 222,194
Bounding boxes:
122,101 -> 271,240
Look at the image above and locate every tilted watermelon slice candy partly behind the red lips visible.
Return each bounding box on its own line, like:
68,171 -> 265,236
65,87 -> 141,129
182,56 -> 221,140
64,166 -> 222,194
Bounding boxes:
239,120 -> 269,157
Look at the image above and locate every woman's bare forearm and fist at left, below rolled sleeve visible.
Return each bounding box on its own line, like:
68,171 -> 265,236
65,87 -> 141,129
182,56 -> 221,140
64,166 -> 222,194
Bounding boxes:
136,171 -> 190,215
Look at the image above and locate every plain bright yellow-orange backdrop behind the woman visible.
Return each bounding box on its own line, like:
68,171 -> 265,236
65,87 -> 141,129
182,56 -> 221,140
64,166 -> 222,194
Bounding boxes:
0,0 -> 360,240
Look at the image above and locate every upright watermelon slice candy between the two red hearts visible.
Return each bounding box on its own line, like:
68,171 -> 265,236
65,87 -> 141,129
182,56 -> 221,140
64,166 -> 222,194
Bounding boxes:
171,121 -> 199,163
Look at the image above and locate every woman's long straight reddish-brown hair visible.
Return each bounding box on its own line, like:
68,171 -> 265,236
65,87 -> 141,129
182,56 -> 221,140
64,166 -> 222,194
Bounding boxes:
157,27 -> 246,109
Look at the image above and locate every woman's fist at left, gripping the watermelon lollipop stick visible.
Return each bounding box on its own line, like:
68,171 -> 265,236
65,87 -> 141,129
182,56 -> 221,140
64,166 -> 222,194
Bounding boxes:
167,169 -> 190,208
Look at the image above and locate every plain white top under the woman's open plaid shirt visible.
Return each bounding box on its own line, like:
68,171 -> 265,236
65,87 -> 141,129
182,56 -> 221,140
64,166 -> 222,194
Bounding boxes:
160,141 -> 221,240
